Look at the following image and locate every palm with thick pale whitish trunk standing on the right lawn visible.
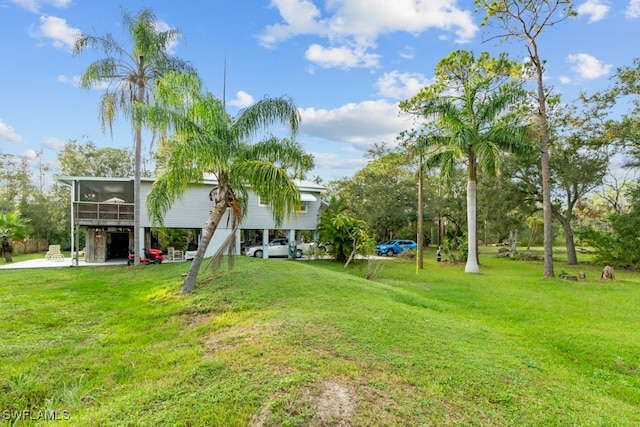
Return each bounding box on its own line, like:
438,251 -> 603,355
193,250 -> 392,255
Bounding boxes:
401,51 -> 529,273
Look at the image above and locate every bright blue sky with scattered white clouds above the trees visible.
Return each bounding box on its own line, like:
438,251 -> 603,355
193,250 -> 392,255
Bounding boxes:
0,0 -> 640,186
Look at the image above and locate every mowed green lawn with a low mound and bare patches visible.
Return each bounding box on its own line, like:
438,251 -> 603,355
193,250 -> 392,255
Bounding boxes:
0,253 -> 640,426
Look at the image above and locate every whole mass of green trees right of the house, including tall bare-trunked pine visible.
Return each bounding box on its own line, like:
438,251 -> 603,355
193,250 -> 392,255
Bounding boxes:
322,0 -> 640,277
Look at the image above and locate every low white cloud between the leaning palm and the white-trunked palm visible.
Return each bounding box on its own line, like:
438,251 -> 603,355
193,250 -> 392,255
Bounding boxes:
300,100 -> 410,151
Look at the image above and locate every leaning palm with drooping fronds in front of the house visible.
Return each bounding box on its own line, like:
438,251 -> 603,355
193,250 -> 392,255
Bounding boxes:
138,73 -> 312,293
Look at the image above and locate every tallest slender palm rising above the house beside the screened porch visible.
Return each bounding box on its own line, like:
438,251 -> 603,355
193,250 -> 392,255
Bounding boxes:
73,9 -> 195,265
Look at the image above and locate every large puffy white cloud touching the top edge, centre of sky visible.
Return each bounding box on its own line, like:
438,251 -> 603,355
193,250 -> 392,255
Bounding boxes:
259,0 -> 478,68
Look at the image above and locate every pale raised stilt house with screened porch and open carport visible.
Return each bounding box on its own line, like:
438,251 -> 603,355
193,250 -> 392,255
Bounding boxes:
58,176 -> 326,263
